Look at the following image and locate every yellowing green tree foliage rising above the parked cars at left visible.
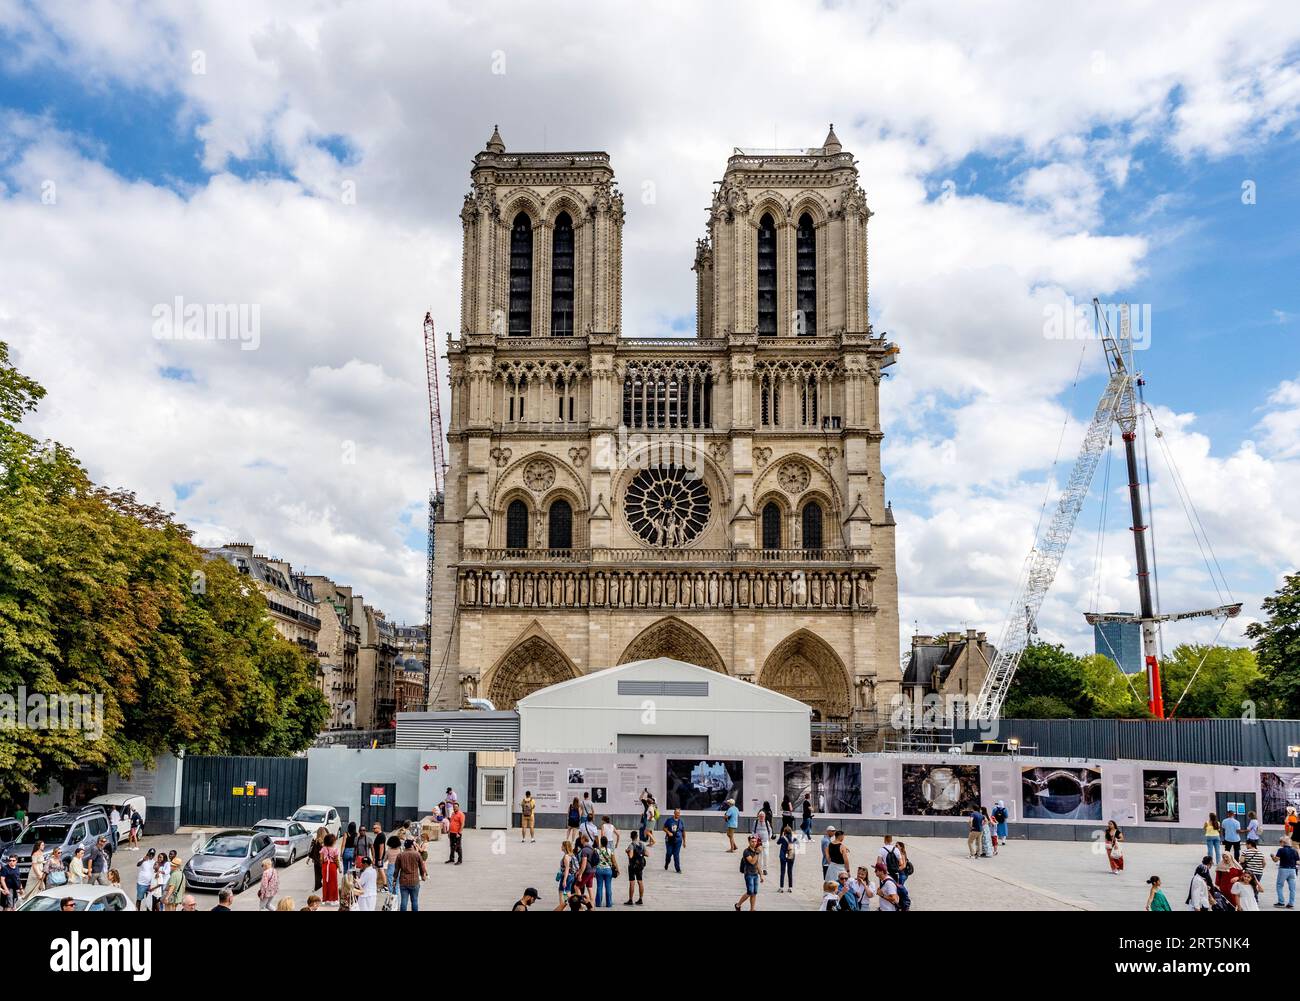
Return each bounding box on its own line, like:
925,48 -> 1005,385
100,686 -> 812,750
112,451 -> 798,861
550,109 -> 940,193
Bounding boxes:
0,342 -> 328,800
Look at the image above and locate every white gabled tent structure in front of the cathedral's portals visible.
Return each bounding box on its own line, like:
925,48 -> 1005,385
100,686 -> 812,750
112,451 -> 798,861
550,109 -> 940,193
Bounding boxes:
517,657 -> 811,757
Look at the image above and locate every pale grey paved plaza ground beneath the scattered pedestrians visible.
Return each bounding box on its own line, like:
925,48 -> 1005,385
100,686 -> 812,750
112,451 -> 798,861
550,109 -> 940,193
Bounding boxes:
114,829 -> 1284,913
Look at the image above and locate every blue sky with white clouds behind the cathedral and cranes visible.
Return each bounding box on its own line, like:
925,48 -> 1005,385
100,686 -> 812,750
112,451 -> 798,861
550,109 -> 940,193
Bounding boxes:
0,0 -> 1300,649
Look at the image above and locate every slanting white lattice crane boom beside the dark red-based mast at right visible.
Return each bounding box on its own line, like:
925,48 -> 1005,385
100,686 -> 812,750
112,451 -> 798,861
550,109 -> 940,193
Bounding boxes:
970,325 -> 1135,720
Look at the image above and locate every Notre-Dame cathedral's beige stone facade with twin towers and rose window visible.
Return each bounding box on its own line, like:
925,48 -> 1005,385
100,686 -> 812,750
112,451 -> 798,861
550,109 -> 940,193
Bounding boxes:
430,129 -> 901,722
